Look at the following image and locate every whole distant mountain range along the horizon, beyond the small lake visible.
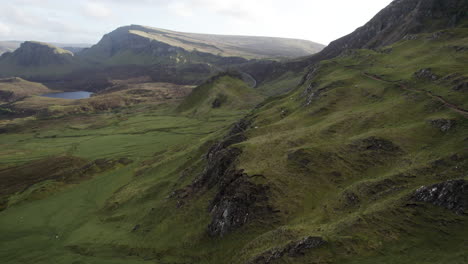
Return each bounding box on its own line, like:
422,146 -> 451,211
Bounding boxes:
0,25 -> 323,91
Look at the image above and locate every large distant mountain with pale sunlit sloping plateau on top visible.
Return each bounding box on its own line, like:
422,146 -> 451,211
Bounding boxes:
82,25 -> 324,58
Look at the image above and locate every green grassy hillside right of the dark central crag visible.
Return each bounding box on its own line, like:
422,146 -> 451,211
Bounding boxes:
231,29 -> 468,263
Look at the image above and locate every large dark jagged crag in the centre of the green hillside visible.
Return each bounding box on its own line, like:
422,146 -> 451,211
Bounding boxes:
191,119 -> 272,236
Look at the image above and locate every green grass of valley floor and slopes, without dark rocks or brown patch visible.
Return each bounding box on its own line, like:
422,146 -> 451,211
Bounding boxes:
0,29 -> 468,263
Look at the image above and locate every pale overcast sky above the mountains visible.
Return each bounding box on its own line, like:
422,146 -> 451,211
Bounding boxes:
0,0 -> 392,44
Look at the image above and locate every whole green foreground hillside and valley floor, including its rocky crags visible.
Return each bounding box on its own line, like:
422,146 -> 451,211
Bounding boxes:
0,19 -> 468,264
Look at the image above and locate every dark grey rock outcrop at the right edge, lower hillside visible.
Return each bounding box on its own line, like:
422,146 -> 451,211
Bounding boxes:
411,180 -> 468,215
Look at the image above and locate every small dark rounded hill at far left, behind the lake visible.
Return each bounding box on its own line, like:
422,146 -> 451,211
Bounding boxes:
0,41 -> 75,77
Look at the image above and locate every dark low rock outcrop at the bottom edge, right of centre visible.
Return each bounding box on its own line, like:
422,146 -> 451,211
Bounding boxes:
248,236 -> 327,264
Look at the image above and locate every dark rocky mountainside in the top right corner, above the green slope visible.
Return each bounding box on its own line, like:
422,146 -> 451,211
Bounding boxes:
318,0 -> 468,58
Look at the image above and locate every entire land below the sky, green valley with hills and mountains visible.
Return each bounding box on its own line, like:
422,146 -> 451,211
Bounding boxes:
0,0 -> 468,264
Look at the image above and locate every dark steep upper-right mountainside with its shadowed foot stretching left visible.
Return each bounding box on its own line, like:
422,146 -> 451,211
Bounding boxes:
242,0 -> 468,89
